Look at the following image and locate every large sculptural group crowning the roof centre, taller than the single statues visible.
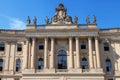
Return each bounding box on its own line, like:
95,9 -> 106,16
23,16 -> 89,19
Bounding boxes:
51,3 -> 72,24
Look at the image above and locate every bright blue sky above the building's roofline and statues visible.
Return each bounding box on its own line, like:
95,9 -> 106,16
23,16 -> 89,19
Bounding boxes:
0,0 -> 120,29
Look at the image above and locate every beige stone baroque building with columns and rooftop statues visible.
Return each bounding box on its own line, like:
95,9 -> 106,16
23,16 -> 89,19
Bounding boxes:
0,4 -> 120,80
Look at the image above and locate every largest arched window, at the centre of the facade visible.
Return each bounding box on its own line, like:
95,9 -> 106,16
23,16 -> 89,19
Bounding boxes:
57,50 -> 67,69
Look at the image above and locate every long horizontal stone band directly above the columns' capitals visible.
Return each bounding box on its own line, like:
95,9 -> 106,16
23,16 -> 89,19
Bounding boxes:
26,32 -> 98,37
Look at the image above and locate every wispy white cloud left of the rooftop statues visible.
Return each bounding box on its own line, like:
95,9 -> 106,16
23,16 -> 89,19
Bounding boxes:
9,18 -> 26,29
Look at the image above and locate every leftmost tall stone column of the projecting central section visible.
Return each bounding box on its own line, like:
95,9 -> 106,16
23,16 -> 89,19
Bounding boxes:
23,40 -> 29,69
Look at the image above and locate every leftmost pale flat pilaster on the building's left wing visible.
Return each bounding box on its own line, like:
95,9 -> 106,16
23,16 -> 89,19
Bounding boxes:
4,42 -> 10,71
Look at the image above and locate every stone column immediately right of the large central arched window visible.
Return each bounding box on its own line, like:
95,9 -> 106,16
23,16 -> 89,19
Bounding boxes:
69,37 -> 73,68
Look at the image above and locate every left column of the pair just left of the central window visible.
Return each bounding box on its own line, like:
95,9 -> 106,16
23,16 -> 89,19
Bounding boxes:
44,38 -> 48,69
